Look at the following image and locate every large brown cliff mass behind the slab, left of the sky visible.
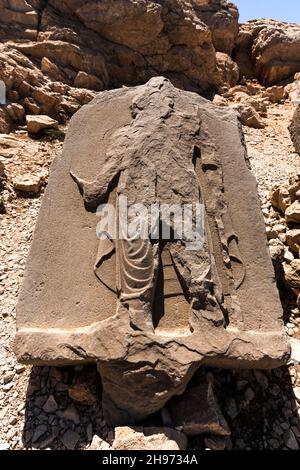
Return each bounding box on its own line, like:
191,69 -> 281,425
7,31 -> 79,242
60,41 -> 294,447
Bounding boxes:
0,0 -> 227,120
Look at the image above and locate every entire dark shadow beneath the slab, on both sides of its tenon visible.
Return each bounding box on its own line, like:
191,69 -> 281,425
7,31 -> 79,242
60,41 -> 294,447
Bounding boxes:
23,366 -> 300,450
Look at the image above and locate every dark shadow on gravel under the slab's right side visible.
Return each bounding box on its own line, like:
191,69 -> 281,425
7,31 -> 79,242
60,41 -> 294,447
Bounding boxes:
185,366 -> 300,450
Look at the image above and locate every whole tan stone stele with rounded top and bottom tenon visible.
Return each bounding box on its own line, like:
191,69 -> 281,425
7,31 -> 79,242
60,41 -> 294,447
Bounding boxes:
15,77 -> 289,425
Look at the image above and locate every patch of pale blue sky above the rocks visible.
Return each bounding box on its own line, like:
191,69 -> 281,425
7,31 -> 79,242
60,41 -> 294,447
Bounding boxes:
231,0 -> 300,23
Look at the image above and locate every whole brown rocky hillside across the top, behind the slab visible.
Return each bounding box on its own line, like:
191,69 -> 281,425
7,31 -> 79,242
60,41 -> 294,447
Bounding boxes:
0,0 -> 300,133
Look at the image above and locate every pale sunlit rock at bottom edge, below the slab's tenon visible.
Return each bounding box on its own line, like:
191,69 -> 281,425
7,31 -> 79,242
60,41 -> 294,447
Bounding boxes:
112,427 -> 187,450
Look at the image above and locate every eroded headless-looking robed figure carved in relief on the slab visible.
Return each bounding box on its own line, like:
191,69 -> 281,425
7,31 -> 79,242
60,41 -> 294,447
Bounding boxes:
72,79 -> 244,331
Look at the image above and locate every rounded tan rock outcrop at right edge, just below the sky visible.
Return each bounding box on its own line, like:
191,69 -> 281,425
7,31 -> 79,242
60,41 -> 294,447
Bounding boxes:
235,20 -> 300,86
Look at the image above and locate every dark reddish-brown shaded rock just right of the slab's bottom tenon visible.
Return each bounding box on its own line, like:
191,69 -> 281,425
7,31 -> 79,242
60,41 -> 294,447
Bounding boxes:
170,381 -> 230,436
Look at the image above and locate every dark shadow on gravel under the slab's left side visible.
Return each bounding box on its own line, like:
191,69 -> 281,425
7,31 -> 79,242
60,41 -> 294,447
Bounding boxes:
23,366 -> 110,450
